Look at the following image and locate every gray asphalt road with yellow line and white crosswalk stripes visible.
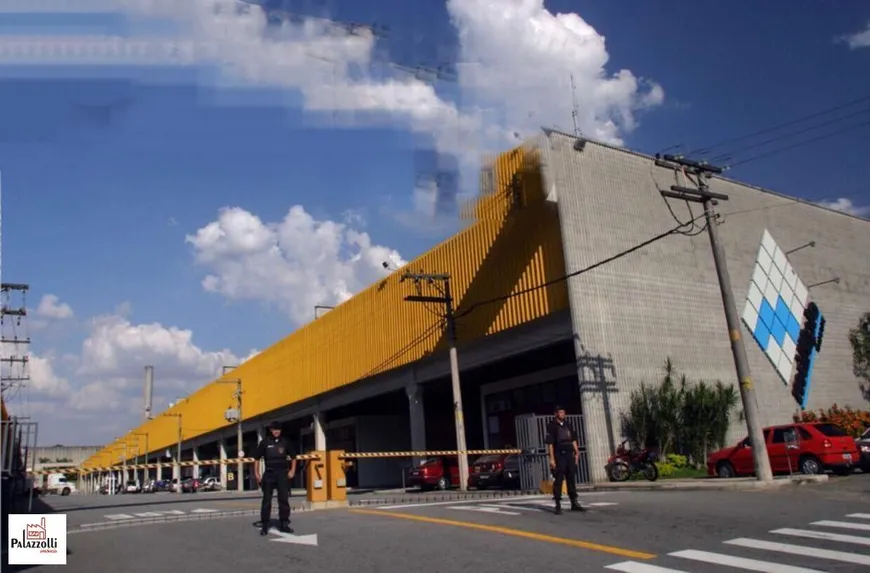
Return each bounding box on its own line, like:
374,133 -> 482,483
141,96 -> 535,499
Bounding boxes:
4,475 -> 870,573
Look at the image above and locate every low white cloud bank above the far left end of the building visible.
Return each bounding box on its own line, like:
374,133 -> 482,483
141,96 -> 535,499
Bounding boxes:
16,305 -> 258,444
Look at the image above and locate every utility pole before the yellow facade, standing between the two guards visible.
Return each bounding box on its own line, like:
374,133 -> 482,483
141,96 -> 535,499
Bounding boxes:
399,271 -> 468,491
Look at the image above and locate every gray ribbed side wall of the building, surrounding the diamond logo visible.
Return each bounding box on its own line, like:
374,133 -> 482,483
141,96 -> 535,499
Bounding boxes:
541,133 -> 870,480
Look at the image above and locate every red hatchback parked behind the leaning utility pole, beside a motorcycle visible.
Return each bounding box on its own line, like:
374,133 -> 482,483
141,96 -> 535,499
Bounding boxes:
707,423 -> 860,478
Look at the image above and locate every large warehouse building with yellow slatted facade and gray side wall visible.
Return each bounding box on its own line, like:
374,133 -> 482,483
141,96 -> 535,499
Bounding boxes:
85,131 -> 870,487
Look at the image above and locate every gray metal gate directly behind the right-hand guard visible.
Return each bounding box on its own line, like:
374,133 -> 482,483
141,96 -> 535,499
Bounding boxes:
514,414 -> 589,490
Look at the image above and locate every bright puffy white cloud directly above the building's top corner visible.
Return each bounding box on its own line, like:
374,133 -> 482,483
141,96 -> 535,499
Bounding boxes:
447,0 -> 664,143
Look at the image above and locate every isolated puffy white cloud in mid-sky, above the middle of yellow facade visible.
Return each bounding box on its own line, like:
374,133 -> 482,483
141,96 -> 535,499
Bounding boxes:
187,205 -> 405,324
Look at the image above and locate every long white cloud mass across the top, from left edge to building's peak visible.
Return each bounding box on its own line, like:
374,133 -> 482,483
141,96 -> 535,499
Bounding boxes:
0,0 -> 664,214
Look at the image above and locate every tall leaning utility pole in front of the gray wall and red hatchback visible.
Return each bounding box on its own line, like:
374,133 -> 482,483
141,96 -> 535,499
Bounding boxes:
656,155 -> 773,482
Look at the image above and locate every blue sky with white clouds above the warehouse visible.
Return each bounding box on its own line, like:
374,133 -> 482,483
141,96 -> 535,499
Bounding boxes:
0,0 -> 870,445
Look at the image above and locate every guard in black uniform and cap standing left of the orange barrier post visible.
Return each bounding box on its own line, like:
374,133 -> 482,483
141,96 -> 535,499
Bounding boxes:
254,422 -> 296,535
